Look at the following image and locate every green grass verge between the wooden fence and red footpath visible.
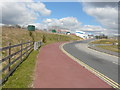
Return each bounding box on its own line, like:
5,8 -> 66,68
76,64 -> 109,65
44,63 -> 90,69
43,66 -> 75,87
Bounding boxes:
3,50 -> 39,88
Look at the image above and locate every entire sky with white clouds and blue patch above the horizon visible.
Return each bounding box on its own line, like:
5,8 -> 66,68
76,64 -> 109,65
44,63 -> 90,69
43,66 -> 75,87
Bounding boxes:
0,0 -> 118,35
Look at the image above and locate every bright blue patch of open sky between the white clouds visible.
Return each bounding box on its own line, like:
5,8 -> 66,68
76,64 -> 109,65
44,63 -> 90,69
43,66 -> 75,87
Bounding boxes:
41,2 -> 100,25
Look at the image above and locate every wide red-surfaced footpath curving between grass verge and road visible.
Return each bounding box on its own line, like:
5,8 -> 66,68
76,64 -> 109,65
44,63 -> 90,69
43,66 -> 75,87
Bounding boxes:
33,42 -> 111,88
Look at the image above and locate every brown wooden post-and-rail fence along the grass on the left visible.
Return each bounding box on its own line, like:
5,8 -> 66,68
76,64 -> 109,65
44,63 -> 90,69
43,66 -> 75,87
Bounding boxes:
0,41 -> 42,85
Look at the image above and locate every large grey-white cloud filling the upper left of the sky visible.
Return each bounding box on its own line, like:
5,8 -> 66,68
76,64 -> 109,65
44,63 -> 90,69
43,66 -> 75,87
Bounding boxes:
0,2 -> 51,24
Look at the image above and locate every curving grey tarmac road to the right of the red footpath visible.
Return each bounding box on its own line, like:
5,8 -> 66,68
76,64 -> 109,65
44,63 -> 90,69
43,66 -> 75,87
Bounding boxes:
63,39 -> 118,83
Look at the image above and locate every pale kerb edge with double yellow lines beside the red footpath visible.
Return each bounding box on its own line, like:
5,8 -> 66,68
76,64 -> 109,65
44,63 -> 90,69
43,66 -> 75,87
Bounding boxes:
59,42 -> 120,89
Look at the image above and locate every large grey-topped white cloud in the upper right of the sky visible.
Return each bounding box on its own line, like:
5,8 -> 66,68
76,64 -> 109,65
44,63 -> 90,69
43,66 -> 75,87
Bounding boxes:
83,2 -> 118,33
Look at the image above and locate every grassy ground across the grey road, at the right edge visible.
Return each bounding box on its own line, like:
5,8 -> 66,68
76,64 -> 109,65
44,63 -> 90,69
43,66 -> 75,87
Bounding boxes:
91,39 -> 120,52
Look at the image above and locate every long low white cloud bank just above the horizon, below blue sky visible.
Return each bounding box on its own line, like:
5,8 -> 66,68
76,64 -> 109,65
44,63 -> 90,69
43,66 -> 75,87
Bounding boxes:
36,17 -> 107,34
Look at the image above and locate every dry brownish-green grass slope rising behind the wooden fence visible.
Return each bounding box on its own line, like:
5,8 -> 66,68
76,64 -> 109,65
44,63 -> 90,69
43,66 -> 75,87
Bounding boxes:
2,27 -> 81,46
